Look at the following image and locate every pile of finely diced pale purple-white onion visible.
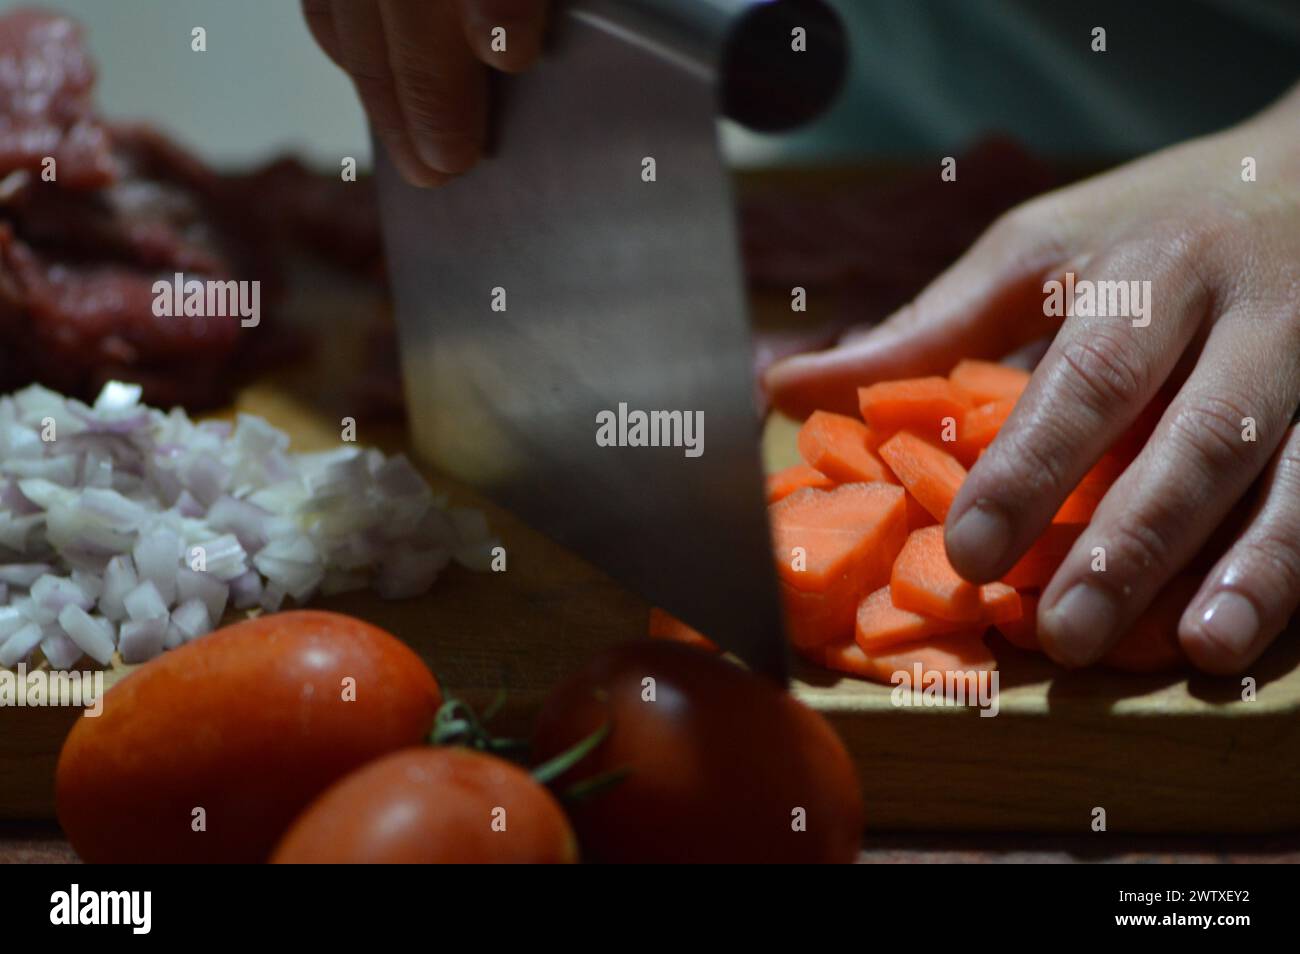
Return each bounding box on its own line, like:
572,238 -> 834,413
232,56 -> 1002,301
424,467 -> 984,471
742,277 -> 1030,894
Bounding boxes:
0,382 -> 497,669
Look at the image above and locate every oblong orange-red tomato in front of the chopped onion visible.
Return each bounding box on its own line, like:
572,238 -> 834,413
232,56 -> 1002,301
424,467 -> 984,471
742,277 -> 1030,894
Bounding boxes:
55,611 -> 441,862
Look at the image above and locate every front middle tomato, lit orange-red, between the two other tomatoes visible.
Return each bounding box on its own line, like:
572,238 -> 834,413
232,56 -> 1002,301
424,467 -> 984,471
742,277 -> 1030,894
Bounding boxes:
272,747 -> 577,864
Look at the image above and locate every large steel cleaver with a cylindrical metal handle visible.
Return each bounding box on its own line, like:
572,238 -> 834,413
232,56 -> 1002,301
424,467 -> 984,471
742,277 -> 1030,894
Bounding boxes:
376,0 -> 846,680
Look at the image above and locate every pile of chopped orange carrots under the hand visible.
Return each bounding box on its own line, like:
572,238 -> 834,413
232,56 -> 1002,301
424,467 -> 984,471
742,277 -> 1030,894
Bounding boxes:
651,361 -> 1199,682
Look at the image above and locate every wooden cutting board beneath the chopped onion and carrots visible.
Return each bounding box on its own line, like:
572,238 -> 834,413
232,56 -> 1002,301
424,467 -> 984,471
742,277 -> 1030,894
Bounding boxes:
0,385 -> 1300,837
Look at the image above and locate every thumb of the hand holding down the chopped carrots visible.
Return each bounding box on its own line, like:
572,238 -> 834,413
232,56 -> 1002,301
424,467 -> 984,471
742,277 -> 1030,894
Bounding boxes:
763,207 -> 1063,417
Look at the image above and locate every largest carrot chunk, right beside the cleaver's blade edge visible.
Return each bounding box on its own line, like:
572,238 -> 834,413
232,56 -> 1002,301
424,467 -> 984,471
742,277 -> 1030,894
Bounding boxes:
768,483 -> 907,646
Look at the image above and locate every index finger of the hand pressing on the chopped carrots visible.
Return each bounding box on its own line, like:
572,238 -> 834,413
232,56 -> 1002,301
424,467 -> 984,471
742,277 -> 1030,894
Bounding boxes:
946,246 -> 1209,582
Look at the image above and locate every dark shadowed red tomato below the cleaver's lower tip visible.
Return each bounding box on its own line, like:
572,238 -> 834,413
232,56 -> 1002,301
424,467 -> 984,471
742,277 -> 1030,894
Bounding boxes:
533,641 -> 863,863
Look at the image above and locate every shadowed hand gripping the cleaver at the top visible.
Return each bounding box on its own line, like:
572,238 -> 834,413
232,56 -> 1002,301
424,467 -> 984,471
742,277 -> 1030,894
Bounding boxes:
303,0 -> 546,186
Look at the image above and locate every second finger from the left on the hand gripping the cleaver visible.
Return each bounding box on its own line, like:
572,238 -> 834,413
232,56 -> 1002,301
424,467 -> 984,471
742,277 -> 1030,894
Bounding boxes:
330,0 -> 449,186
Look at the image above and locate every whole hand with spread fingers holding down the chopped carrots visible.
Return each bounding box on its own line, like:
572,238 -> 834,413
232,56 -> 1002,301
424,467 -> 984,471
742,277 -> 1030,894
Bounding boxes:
766,82 -> 1300,672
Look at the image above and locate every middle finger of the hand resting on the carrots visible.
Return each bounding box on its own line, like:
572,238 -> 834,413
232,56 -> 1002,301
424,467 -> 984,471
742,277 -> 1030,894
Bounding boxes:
1039,312 -> 1300,665
